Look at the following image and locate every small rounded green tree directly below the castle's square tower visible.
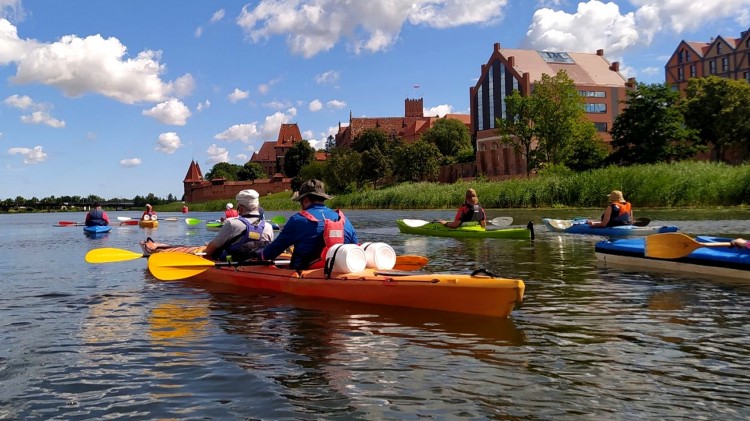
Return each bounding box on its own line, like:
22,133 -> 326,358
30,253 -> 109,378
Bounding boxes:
393,140 -> 443,181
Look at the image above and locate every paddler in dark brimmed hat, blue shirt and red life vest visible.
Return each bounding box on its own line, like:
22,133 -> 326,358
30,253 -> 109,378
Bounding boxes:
257,179 -> 359,269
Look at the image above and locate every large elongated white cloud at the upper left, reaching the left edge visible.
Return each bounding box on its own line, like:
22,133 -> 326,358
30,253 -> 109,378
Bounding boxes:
0,19 -> 191,104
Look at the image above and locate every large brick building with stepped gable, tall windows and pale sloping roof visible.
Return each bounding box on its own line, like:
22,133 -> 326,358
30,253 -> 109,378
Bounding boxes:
469,43 -> 635,179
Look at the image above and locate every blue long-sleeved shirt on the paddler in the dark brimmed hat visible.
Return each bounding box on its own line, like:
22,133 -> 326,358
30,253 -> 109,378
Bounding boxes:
261,203 -> 359,269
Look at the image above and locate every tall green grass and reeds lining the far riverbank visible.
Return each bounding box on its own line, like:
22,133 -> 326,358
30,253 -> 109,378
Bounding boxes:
160,161 -> 750,211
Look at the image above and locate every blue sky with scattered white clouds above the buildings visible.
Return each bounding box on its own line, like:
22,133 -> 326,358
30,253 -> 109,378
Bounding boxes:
0,0 -> 750,200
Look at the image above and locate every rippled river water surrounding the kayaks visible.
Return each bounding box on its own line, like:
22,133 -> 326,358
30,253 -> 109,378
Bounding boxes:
0,210 -> 750,420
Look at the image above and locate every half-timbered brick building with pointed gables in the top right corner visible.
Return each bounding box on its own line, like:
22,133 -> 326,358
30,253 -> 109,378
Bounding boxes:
664,28 -> 750,92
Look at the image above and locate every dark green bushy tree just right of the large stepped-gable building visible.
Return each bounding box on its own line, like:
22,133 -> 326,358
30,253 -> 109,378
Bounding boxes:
609,83 -> 700,164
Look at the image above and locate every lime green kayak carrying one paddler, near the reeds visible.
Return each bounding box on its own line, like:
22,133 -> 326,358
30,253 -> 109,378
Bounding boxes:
396,219 -> 534,239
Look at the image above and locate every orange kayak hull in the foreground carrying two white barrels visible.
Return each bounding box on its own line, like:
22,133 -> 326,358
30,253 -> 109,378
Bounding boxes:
195,266 -> 525,317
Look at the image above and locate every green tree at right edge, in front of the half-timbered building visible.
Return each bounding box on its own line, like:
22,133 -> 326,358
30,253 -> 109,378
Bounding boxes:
684,76 -> 750,161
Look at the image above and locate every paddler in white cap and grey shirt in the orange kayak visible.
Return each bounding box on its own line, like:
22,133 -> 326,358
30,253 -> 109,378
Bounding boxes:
205,189 -> 273,262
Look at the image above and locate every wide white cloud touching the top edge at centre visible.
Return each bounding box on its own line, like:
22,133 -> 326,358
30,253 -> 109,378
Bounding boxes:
237,0 -> 508,58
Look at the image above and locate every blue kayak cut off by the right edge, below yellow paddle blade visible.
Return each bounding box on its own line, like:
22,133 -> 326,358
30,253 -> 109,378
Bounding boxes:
594,237 -> 750,280
